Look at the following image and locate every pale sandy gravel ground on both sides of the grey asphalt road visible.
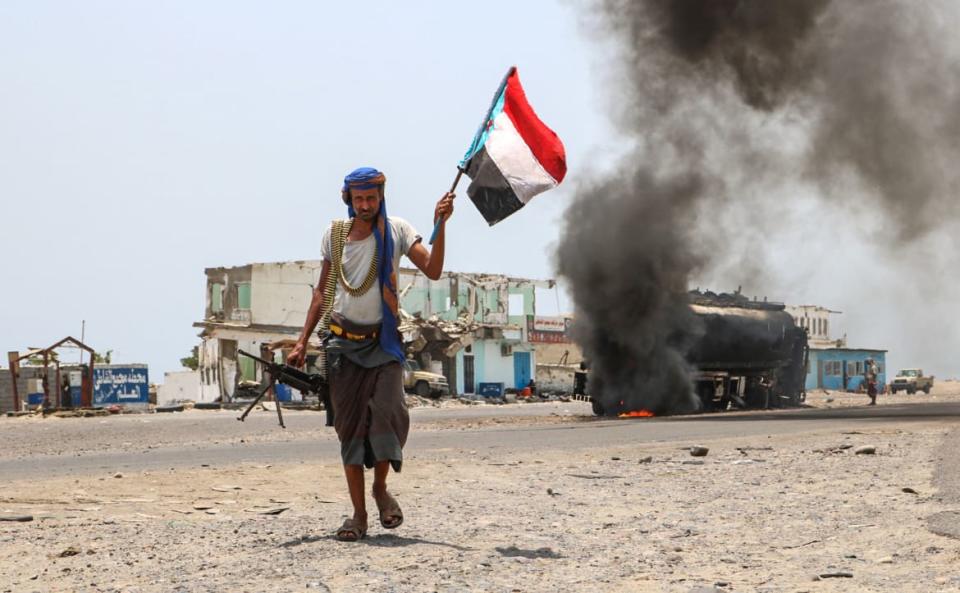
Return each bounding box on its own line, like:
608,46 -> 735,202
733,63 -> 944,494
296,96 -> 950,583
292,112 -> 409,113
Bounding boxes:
0,383 -> 960,593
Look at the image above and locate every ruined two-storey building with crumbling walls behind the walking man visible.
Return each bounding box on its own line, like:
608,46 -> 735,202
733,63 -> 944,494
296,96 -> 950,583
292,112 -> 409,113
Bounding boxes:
194,260 -> 572,401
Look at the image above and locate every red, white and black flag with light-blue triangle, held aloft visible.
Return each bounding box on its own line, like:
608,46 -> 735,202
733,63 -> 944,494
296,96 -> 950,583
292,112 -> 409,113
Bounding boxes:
460,67 -> 567,226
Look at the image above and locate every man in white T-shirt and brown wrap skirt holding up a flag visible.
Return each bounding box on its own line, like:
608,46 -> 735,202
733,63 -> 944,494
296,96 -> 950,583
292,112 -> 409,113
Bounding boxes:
287,167 -> 454,541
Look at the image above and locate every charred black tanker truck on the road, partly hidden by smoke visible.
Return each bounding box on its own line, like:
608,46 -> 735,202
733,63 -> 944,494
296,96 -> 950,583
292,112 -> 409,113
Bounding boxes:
575,290 -> 808,416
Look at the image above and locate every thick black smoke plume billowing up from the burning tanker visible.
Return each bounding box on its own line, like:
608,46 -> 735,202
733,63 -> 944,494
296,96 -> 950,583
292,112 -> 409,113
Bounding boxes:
557,0 -> 960,413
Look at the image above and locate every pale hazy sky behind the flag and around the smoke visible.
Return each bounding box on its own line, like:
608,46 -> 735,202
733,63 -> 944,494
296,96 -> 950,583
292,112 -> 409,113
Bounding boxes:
0,0 -> 960,382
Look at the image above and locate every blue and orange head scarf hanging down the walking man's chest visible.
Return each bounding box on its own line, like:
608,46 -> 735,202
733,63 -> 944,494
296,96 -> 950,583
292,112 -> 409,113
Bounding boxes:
342,167 -> 405,362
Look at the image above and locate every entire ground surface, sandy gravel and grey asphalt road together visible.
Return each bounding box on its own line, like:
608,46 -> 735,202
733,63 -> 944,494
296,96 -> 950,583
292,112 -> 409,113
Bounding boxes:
0,383 -> 960,593
